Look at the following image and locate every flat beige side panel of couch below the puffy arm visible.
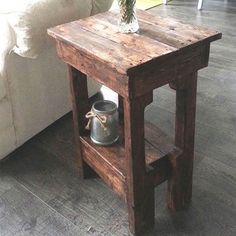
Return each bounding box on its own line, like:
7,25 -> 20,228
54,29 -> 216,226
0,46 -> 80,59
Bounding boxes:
7,47 -> 100,145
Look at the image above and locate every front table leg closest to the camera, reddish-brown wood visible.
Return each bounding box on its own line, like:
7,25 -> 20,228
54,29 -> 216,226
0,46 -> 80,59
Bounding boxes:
124,94 -> 154,236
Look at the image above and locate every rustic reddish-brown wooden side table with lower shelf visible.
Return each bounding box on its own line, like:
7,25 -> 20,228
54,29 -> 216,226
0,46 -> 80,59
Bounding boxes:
48,11 -> 221,235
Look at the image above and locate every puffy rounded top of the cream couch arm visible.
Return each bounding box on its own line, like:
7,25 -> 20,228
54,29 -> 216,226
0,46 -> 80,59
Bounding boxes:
0,0 -> 92,58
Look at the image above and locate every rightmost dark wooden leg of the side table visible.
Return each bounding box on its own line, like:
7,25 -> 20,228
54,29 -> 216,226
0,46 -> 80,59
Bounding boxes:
167,72 -> 197,210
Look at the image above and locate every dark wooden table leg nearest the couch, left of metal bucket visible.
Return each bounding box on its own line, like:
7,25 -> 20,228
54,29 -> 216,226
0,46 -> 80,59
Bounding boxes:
68,65 -> 96,178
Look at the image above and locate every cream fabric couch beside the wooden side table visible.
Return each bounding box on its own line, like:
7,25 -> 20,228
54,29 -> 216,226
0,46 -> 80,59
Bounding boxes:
0,0 -> 113,159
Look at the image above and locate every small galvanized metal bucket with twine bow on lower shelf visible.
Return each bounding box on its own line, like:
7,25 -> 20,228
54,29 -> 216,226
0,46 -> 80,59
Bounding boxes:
86,100 -> 119,146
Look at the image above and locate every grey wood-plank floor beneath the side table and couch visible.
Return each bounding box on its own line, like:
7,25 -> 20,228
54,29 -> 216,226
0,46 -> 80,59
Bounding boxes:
0,0 -> 236,236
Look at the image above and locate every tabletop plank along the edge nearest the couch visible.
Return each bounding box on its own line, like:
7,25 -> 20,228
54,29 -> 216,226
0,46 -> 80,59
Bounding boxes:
48,21 -> 152,74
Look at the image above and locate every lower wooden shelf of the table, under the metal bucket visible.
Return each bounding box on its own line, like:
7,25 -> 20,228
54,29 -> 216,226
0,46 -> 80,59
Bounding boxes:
80,122 -> 182,199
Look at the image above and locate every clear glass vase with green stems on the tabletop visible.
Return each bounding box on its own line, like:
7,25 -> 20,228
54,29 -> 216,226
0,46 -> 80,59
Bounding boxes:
118,0 -> 139,33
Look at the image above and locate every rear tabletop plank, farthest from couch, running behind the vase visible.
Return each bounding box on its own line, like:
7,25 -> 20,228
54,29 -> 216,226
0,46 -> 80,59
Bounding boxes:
91,10 -> 221,48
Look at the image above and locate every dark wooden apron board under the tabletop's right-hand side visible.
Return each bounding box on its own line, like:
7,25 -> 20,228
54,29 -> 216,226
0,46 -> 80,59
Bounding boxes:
130,44 -> 209,96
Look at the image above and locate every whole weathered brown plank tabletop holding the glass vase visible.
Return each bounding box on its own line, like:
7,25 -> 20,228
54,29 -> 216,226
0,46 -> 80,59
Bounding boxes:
48,10 -> 221,74
